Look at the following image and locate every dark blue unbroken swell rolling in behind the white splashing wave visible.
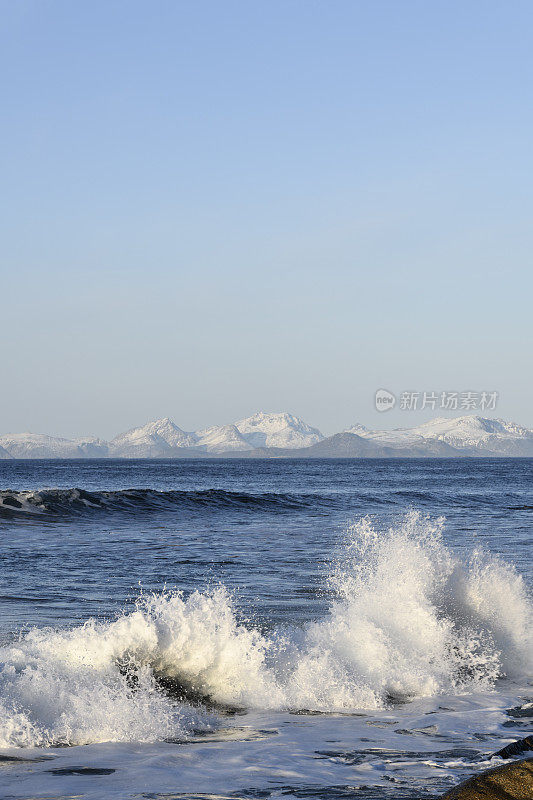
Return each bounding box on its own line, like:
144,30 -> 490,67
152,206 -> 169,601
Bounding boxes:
0,488 -> 335,519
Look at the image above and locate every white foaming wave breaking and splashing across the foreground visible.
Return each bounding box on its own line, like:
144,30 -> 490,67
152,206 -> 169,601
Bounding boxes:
0,512 -> 533,747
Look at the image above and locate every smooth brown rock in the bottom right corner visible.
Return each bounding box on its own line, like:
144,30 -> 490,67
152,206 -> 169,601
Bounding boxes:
442,758 -> 533,800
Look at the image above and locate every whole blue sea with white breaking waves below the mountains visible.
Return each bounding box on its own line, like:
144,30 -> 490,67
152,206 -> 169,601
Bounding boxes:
0,459 -> 533,800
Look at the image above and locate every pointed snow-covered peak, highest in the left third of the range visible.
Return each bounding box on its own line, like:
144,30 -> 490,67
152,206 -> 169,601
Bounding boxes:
109,417 -> 197,458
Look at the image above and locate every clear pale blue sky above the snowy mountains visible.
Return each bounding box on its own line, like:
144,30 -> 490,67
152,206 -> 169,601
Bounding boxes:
0,0 -> 533,438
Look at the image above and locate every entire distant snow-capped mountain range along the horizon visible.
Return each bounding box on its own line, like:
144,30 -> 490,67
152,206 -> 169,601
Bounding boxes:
0,412 -> 533,459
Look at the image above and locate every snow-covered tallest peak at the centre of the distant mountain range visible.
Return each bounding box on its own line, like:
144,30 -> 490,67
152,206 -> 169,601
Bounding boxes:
235,411 -> 324,449
